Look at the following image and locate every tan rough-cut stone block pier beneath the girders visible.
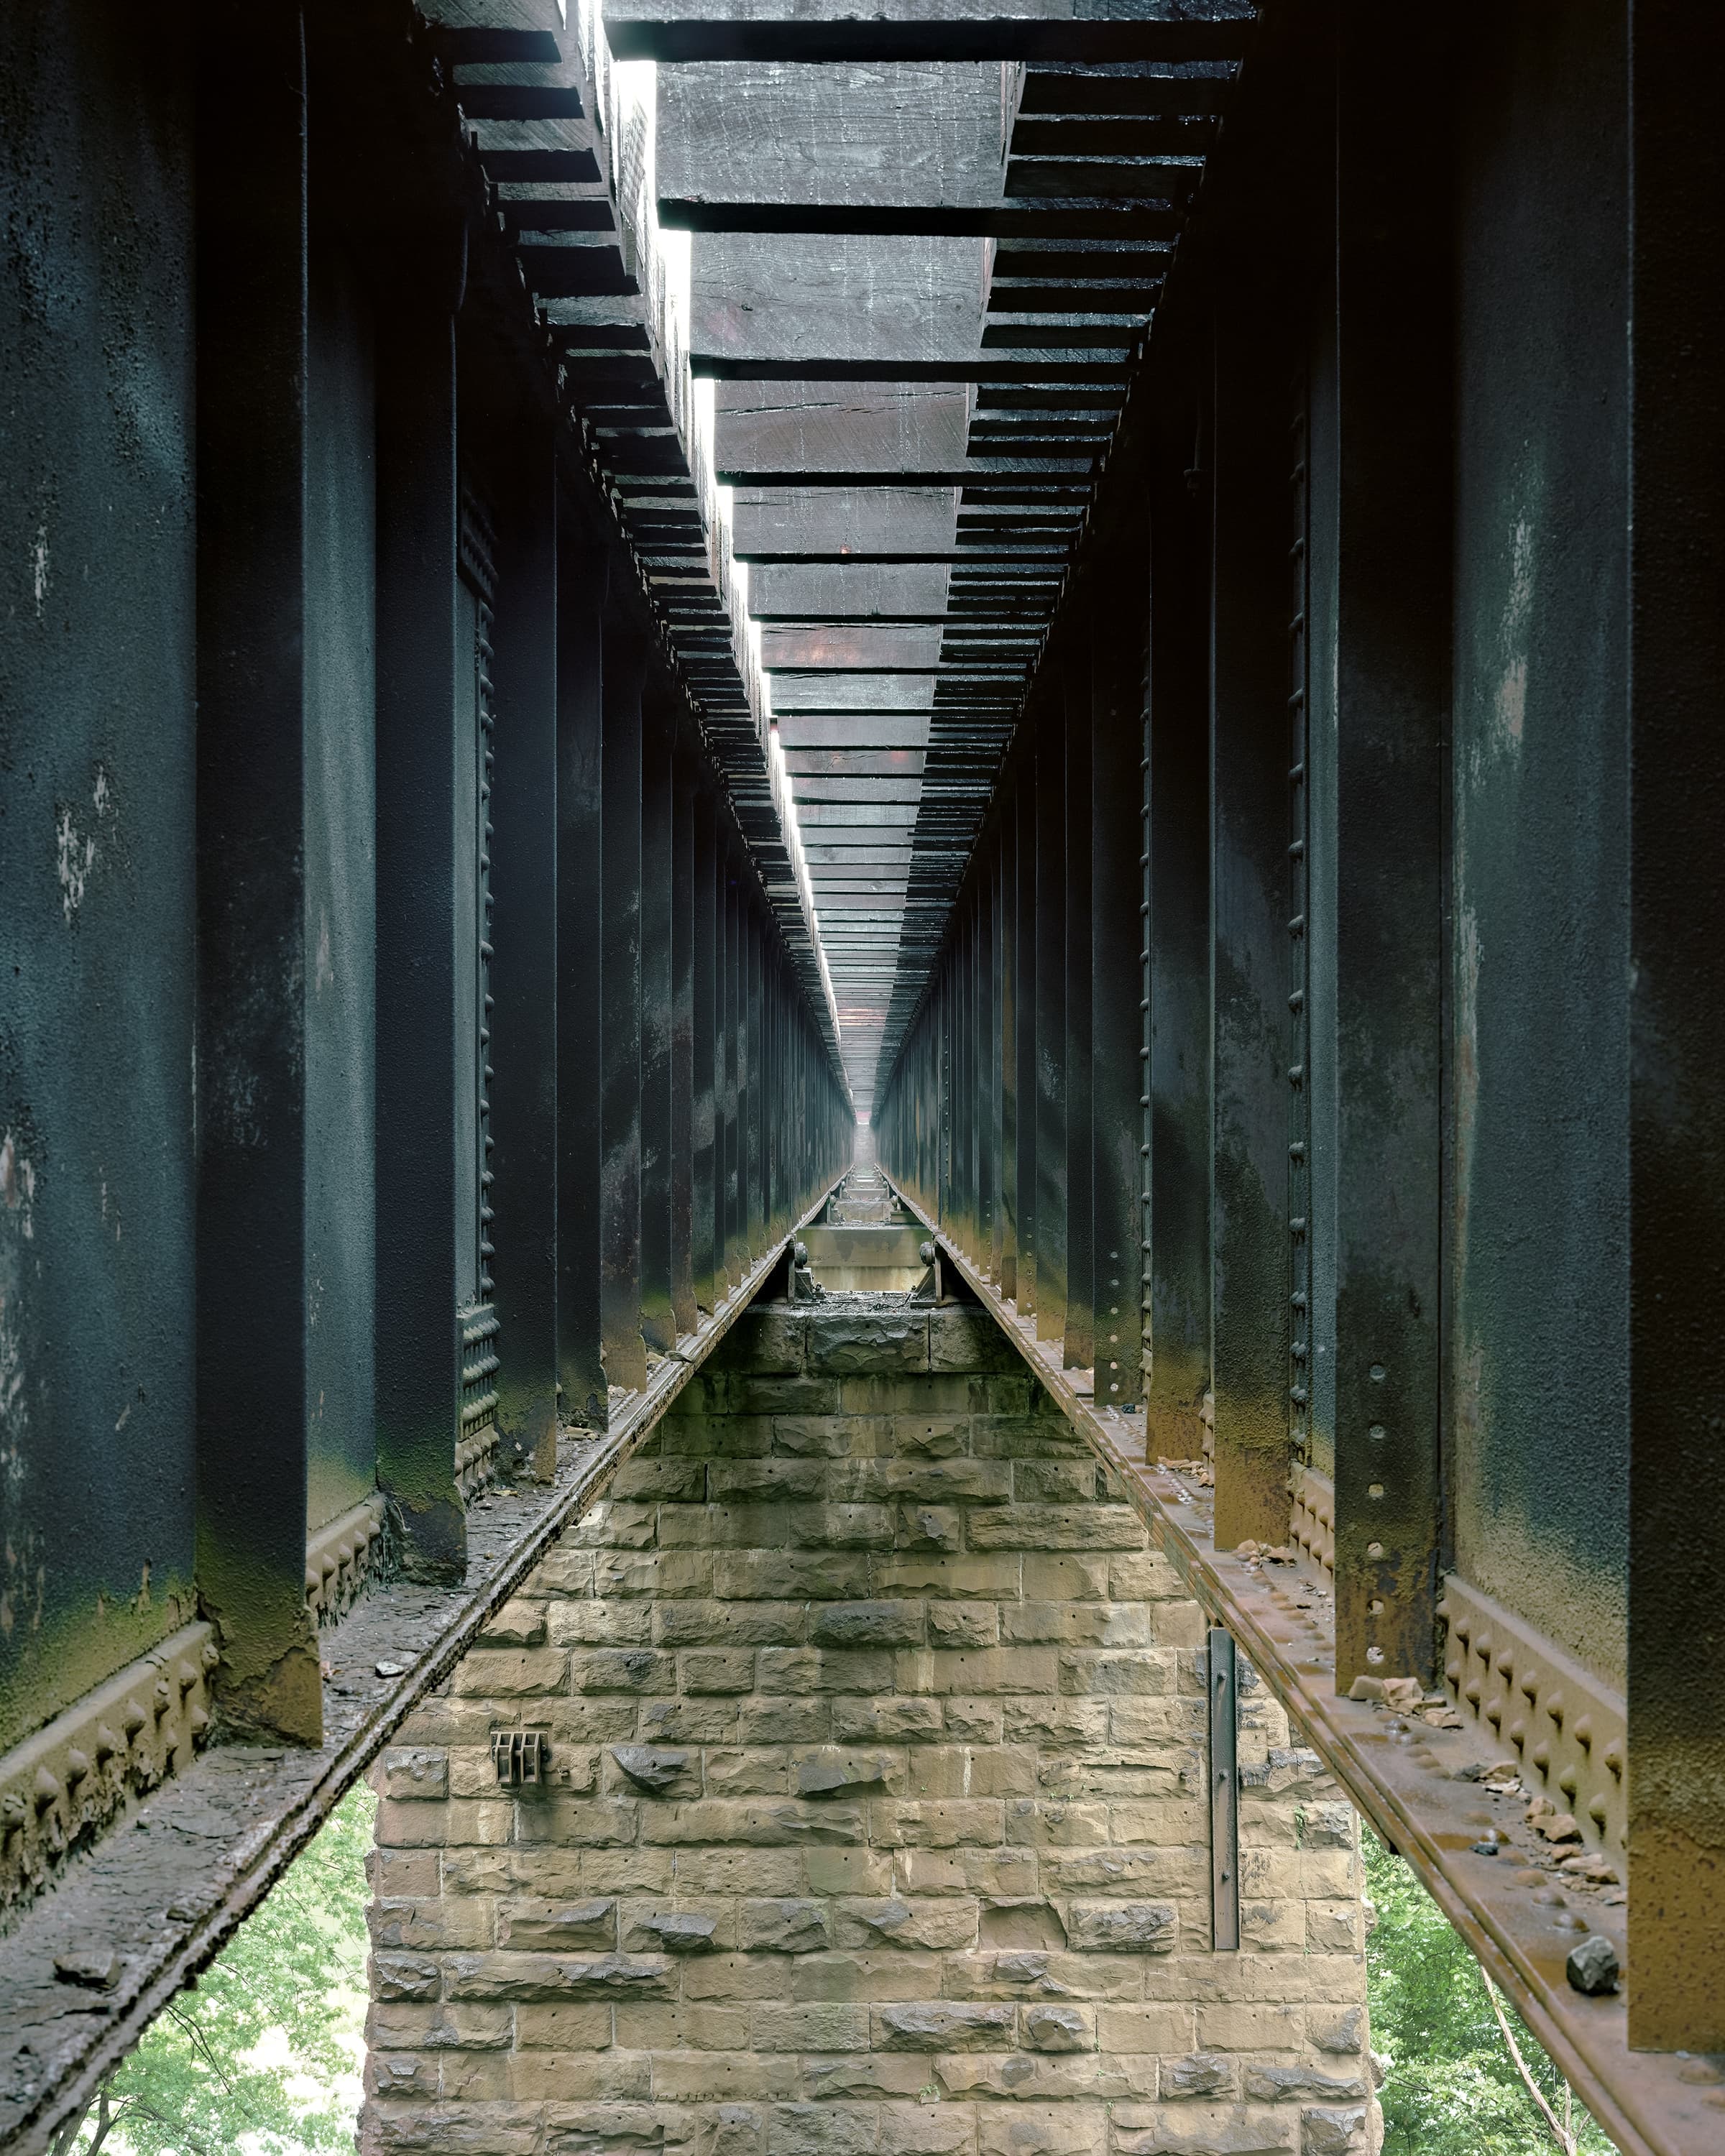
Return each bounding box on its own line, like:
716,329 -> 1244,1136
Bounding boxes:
360,1304 -> 1380,2156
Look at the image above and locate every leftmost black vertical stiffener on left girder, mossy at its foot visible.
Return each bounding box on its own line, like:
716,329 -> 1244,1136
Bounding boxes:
195,11 -> 323,1742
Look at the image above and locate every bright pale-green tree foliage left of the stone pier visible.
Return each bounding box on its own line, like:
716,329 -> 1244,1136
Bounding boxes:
65,1783 -> 377,2156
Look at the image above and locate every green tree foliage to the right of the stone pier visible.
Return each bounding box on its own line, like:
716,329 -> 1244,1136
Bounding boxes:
1365,1828 -> 1613,2156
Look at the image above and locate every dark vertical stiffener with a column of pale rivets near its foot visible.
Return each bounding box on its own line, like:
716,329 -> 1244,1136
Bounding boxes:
1313,15 -> 1451,1688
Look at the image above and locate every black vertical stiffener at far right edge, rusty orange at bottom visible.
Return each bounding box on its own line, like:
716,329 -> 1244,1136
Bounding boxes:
1626,4 -> 1725,2050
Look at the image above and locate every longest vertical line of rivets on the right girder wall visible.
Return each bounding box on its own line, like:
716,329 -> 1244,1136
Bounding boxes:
1287,388 -> 1311,1462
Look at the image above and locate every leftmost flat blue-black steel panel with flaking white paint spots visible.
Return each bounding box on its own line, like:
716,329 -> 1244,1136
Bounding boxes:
0,4 -> 196,1744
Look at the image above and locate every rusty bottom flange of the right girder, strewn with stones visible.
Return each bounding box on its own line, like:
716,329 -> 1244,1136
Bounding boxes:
893,1184 -> 1725,2156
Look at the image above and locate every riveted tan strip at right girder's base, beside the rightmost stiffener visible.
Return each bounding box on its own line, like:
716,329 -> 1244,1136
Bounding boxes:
1438,1574 -> 1628,1848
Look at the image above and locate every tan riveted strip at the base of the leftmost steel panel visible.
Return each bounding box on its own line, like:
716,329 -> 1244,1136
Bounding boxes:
0,1623 -> 220,1921
